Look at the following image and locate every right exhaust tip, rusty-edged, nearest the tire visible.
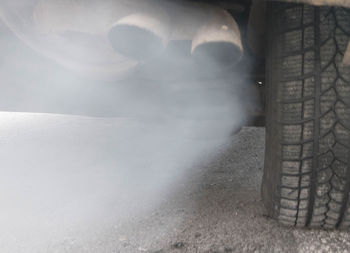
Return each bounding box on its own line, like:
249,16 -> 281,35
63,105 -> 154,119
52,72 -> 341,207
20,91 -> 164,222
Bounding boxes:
192,7 -> 243,68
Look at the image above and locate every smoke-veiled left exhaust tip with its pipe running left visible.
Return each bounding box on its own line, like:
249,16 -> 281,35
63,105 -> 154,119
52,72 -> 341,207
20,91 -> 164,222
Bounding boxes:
33,0 -> 170,61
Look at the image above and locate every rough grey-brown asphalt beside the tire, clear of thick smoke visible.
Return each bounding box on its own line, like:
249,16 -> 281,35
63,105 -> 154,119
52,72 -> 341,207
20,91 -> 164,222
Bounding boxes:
73,128 -> 350,253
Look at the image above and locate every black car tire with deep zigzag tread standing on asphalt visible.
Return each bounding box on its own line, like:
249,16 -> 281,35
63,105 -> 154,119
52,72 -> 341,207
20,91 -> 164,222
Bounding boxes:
262,2 -> 350,229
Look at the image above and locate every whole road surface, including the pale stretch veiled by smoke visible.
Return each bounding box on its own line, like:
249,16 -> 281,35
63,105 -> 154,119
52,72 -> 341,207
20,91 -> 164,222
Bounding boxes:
0,113 -> 350,253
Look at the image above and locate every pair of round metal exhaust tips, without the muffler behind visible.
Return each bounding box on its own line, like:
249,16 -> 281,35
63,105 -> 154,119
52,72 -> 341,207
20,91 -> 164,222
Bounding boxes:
108,7 -> 243,67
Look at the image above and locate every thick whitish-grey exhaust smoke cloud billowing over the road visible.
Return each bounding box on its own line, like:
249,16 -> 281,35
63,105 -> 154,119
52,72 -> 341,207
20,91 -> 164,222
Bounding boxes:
0,0 -> 251,253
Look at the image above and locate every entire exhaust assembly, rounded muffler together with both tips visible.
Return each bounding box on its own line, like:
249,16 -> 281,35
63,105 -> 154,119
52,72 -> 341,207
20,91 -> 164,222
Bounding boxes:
31,0 -> 243,80
